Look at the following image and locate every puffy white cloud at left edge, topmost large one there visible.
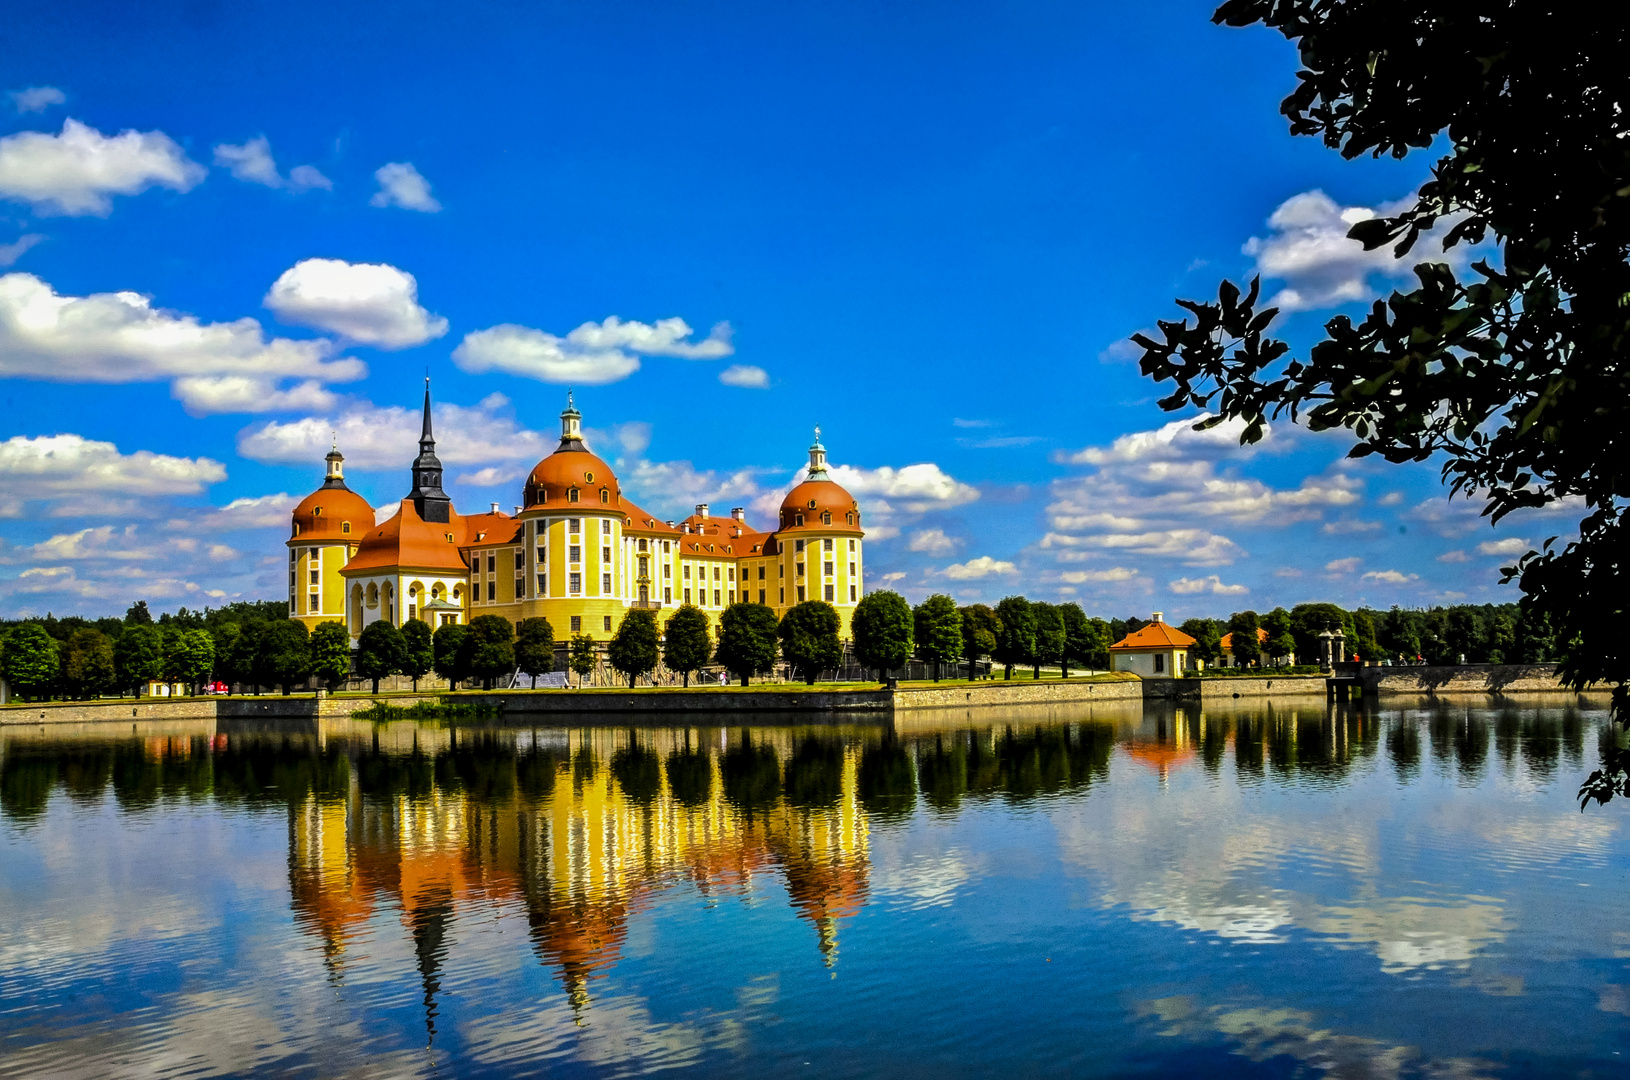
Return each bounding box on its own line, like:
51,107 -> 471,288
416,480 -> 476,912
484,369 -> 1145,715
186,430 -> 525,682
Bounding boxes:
0,119 -> 205,217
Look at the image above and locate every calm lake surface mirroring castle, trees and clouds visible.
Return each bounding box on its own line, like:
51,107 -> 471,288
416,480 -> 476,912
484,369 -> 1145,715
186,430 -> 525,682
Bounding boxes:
0,699 -> 1630,1080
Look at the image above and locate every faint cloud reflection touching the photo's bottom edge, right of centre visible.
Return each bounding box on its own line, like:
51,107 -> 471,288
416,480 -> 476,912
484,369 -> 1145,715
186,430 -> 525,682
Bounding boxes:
1138,997 -> 1498,1078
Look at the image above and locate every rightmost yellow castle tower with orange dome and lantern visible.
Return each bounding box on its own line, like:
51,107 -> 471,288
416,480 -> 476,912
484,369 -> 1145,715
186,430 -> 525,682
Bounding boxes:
773,428 -> 866,639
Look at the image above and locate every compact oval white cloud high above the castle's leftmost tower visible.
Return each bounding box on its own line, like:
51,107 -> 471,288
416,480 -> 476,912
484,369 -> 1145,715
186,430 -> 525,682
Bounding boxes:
264,259 -> 447,349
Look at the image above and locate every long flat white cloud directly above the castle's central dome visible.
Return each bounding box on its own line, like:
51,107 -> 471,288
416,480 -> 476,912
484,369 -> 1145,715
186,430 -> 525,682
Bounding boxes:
453,316 -> 735,386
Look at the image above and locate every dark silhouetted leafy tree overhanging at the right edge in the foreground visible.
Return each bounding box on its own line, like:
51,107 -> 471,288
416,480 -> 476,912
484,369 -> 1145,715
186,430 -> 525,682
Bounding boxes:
1136,0 -> 1630,801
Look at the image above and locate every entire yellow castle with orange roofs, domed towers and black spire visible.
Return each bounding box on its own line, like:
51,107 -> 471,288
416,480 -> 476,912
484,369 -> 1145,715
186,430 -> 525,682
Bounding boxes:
287,381 -> 866,640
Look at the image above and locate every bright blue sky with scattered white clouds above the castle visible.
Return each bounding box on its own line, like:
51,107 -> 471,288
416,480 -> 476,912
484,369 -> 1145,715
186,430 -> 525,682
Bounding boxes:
0,0 -> 1551,617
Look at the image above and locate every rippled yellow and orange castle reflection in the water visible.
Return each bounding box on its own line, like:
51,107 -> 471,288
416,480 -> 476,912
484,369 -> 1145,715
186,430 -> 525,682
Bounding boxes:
289,725 -> 867,1031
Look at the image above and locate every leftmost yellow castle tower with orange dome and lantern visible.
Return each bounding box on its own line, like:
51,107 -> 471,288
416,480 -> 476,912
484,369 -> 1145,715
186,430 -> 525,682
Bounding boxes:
289,443 -> 373,630
